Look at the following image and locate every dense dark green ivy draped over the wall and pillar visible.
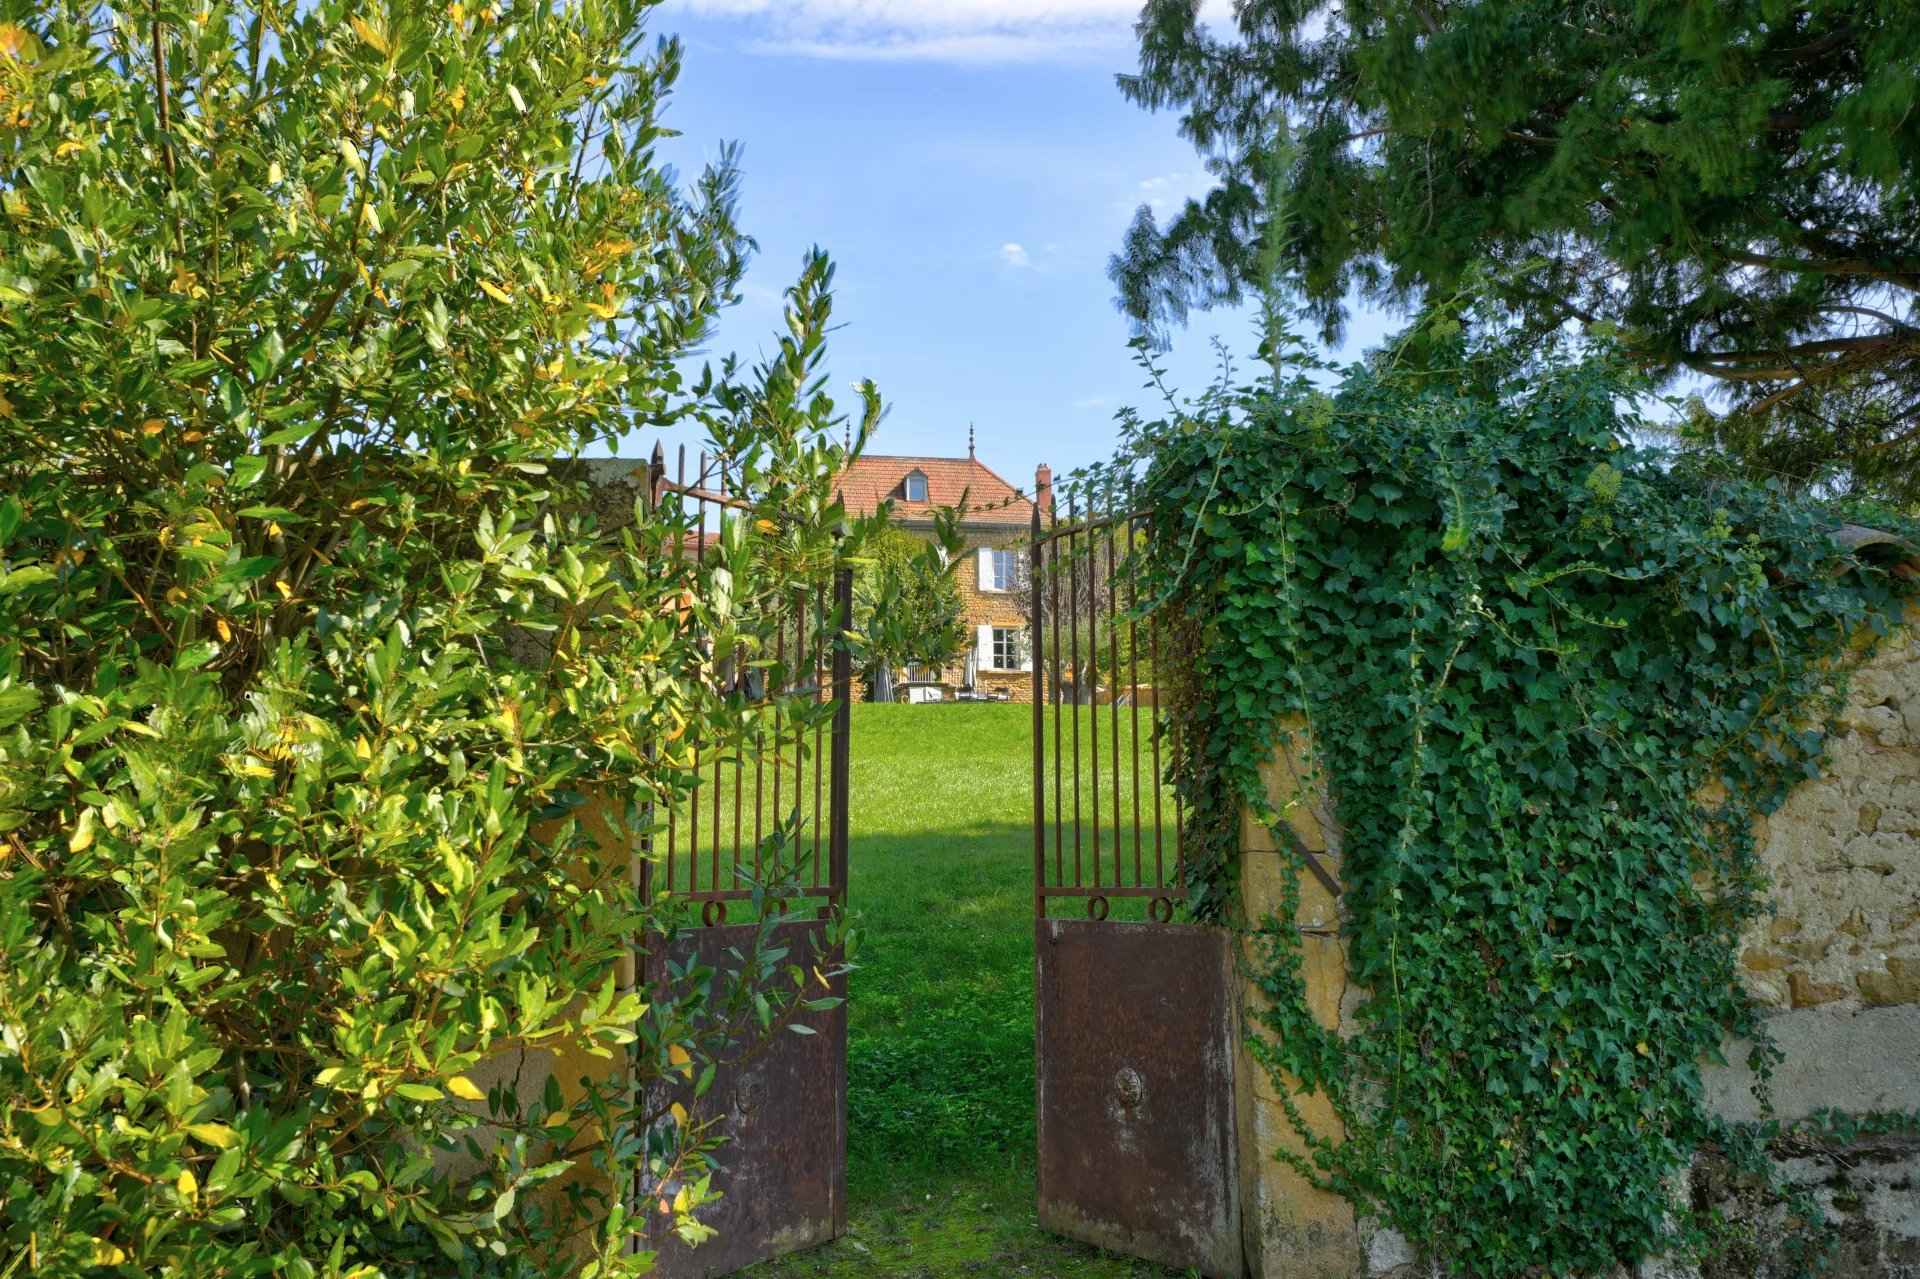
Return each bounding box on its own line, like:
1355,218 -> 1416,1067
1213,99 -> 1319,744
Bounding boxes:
1123,341 -> 1910,1275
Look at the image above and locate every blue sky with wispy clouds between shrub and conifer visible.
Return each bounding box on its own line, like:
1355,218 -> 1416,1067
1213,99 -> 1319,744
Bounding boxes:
622,0 -> 1382,484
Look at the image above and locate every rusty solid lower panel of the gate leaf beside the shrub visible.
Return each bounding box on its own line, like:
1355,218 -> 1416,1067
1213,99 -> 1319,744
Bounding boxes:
645,920 -> 847,1279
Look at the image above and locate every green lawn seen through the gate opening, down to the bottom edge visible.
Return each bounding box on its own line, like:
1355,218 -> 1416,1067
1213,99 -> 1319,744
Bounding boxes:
753,705 -> 1171,1279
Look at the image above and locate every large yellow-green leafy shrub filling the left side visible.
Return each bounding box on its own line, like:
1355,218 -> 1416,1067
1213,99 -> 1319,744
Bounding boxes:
0,0 -> 876,1275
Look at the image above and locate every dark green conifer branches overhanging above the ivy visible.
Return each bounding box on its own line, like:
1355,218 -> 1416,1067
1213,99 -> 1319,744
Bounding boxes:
1112,0 -> 1920,501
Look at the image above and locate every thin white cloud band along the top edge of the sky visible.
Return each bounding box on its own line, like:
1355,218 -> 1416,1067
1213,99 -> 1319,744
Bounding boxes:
670,0 -> 1229,61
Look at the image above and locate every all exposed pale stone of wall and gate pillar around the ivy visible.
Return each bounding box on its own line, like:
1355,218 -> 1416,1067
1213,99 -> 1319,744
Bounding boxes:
1236,607 -> 1920,1279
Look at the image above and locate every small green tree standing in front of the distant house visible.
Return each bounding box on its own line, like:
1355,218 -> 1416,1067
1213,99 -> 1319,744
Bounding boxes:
852,511 -> 968,689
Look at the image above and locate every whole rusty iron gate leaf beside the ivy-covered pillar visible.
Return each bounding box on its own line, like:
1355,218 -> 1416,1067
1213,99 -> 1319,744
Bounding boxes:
1029,495 -> 1242,1277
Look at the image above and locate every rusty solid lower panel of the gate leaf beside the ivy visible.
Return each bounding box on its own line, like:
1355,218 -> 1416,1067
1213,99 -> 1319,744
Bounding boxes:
1033,920 -> 1240,1275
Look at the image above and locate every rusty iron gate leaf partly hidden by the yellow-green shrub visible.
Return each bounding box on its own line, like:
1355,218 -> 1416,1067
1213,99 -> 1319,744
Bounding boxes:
634,449 -> 852,1279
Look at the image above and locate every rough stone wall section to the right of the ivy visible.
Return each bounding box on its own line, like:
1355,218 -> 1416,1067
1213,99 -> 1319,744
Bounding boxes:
1692,607 -> 1920,1279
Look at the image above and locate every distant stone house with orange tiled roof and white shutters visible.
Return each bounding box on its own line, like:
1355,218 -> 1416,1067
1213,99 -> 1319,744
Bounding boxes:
839,440 -> 1052,701
